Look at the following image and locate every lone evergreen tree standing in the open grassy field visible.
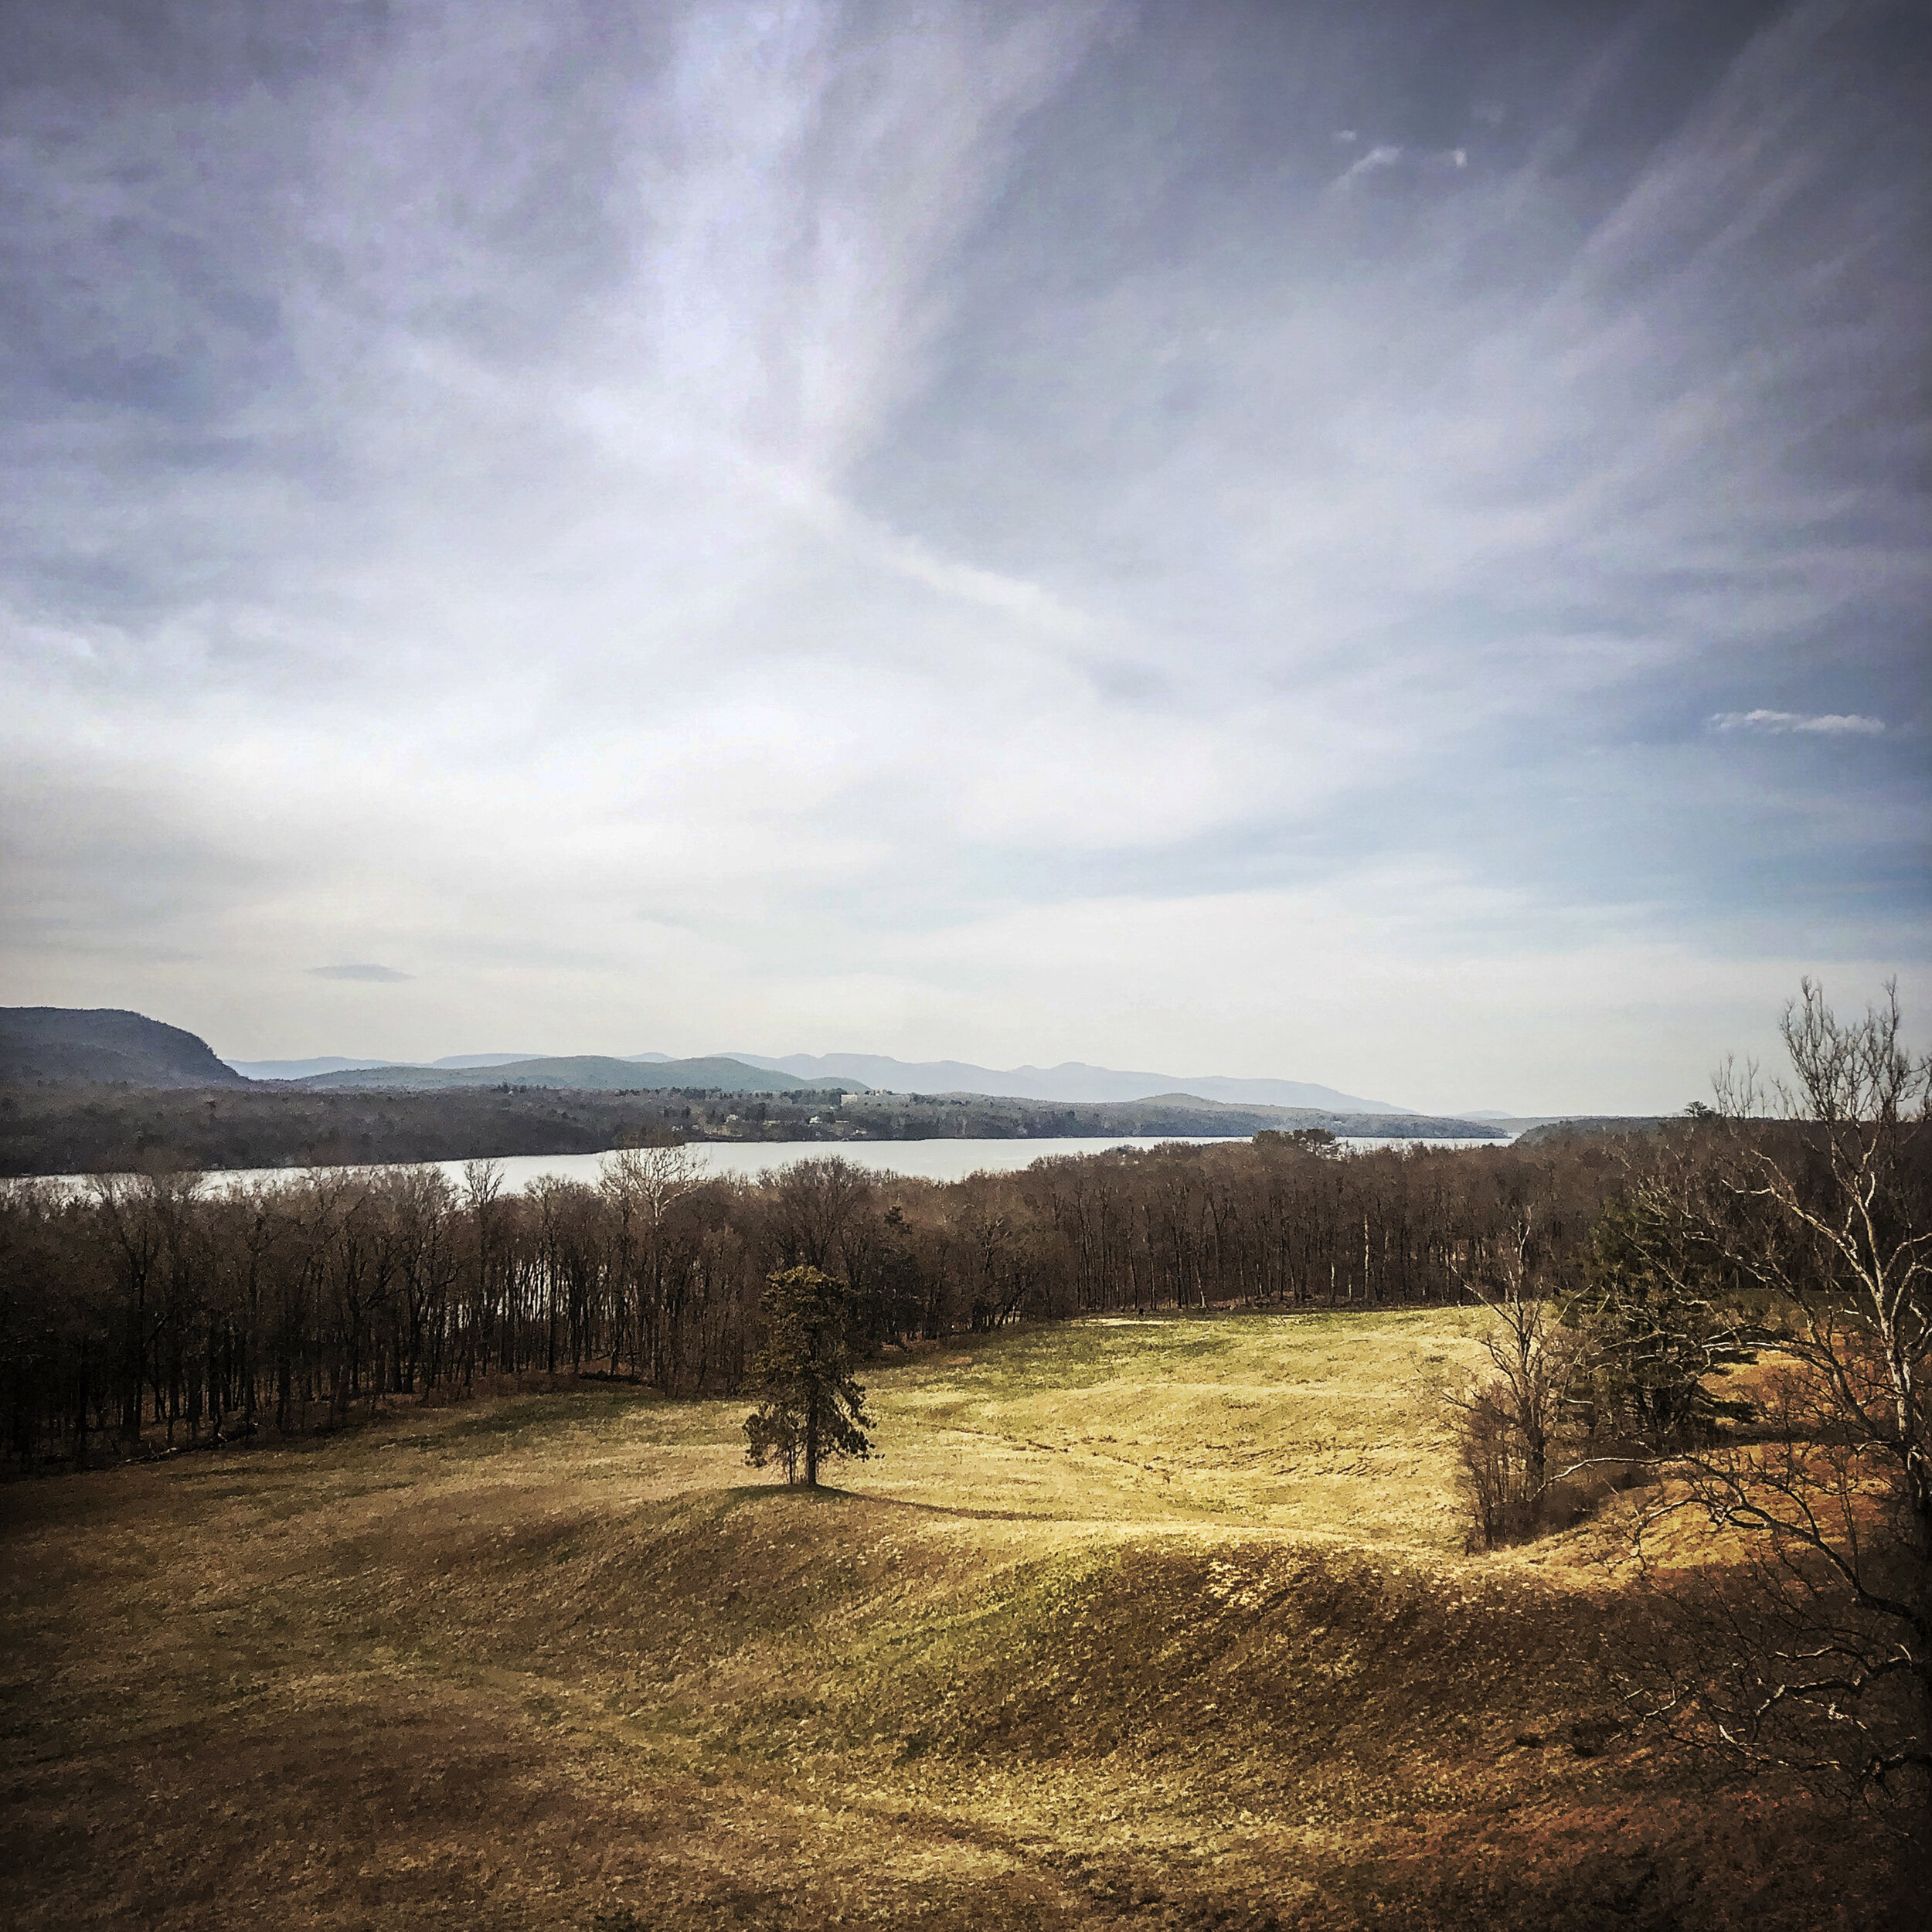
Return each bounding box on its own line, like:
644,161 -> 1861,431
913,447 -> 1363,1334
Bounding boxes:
744,1267 -> 872,1490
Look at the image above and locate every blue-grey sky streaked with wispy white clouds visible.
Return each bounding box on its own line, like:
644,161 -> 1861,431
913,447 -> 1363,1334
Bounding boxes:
0,0 -> 1932,1113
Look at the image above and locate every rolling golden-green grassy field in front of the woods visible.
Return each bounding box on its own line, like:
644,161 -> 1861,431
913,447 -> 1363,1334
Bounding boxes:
0,1312 -> 1917,1932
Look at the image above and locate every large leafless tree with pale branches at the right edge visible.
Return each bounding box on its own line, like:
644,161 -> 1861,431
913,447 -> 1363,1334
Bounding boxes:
1627,980 -> 1932,1828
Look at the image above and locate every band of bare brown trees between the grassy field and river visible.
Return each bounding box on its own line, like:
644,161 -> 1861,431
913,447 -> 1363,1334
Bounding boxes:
0,1136 -> 1621,1467
